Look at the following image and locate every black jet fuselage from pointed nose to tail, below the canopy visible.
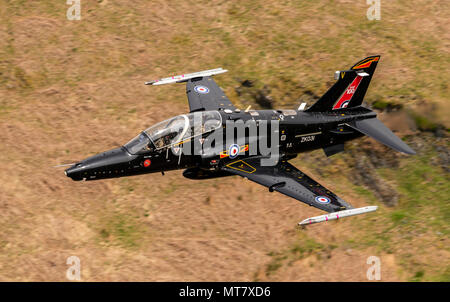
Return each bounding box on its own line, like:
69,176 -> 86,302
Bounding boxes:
66,107 -> 376,180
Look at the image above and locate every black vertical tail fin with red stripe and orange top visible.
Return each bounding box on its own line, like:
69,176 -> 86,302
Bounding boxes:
306,56 -> 380,112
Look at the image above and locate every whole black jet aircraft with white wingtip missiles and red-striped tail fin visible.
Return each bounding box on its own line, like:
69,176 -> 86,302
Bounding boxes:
65,56 -> 415,225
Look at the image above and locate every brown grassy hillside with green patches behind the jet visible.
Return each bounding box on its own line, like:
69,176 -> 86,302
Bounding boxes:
0,0 -> 450,281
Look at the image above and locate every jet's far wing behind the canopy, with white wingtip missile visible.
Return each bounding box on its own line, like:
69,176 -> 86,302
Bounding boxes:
145,68 -> 236,112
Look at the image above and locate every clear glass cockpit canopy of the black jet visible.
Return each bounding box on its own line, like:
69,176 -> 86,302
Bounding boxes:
125,111 -> 222,154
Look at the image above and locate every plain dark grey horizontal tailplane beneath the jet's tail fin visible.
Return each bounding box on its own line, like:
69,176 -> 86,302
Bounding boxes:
348,118 -> 416,154
